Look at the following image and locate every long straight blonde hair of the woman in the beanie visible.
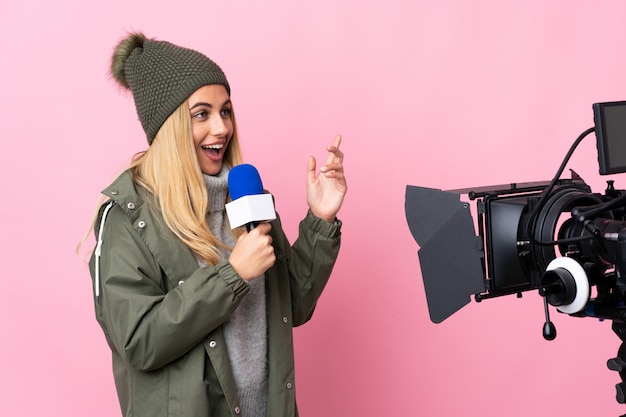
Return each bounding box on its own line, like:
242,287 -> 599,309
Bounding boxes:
79,101 -> 242,265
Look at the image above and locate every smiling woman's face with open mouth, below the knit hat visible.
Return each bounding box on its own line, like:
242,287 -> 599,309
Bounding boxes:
189,84 -> 233,175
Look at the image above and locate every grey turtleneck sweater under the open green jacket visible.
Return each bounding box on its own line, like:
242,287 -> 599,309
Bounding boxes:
198,166 -> 268,417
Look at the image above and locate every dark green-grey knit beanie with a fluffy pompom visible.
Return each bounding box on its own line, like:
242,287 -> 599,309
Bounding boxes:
111,33 -> 230,144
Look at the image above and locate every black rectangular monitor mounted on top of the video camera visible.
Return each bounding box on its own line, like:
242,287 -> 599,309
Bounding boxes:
593,101 -> 626,175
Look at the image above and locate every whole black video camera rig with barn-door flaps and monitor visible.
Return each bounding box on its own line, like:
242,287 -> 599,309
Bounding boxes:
405,101 -> 626,403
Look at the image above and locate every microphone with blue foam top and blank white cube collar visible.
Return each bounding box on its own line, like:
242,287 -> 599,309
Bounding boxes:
226,164 -> 276,231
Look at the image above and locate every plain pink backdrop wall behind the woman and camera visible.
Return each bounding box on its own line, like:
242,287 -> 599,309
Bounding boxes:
0,0 -> 626,417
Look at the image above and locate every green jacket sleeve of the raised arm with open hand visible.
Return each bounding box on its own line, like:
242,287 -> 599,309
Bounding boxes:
288,211 -> 341,326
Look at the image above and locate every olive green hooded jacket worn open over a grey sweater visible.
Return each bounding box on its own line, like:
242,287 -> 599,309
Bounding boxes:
90,171 -> 341,417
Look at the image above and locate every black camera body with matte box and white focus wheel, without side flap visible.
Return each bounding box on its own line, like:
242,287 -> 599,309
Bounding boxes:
468,173 -> 626,321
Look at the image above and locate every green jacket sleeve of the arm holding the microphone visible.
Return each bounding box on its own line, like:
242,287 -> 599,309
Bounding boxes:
90,203 -> 249,371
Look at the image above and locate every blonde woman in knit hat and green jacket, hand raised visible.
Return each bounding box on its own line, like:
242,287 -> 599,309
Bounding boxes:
90,33 -> 347,417
